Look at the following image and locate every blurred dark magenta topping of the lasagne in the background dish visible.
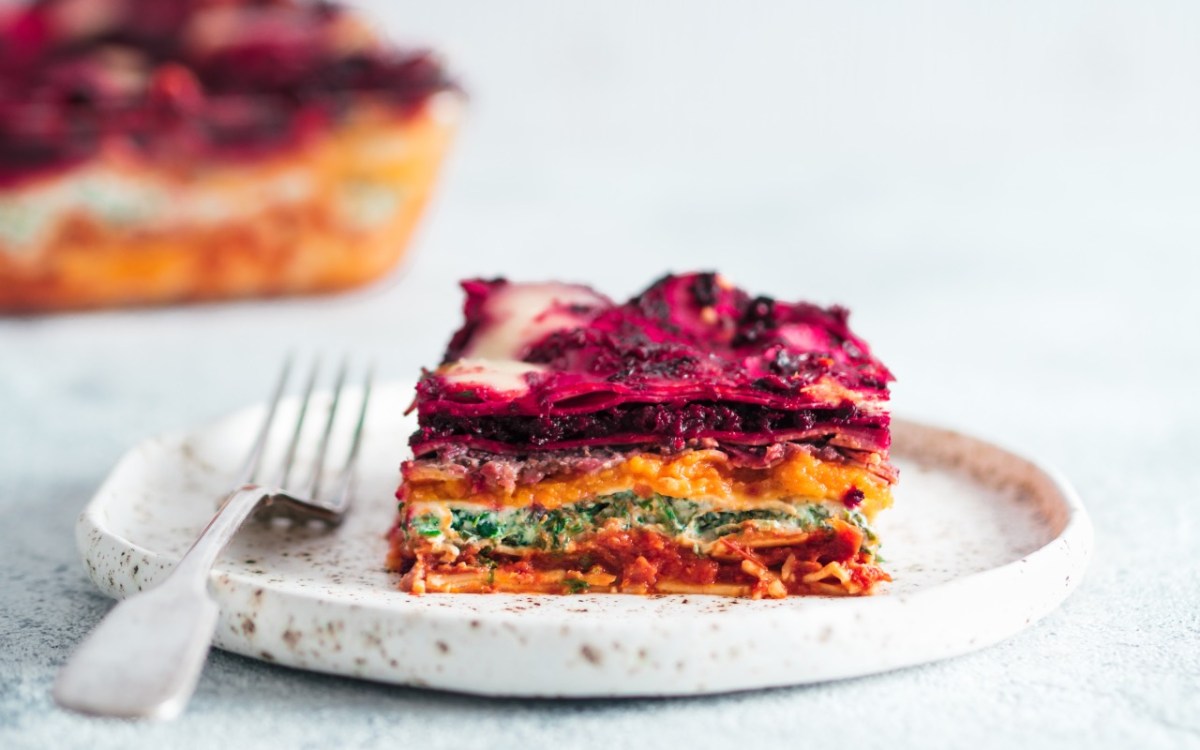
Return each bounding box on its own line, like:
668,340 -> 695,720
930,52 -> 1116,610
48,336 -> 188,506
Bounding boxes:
0,0 -> 450,186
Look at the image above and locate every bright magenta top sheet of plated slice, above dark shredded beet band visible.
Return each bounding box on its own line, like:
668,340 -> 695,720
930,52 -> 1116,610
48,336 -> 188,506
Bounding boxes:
418,274 -> 892,416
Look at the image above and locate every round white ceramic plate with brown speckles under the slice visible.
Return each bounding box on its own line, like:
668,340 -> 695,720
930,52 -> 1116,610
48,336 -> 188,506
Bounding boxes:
77,384 -> 1092,697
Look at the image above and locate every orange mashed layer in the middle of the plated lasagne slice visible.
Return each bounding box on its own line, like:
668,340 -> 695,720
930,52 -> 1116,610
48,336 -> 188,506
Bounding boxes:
402,450 -> 892,518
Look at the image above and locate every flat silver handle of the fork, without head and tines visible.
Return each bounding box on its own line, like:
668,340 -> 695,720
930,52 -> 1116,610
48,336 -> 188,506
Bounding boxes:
54,485 -> 271,719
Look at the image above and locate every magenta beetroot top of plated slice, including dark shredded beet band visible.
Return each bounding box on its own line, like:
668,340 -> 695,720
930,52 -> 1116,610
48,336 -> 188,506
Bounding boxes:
410,274 -> 893,455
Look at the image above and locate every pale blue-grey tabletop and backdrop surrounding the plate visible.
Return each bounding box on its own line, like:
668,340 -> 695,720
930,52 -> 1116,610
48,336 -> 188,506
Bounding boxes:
0,0 -> 1200,749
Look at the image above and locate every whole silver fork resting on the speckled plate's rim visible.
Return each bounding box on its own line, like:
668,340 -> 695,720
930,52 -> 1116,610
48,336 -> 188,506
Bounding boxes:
54,358 -> 372,719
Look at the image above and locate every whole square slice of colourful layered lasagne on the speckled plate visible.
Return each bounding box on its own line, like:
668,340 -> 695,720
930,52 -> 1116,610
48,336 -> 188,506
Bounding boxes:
389,274 -> 896,598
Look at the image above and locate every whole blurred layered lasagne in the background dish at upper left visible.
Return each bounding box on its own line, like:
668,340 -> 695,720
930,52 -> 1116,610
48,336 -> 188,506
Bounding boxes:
0,0 -> 460,312
